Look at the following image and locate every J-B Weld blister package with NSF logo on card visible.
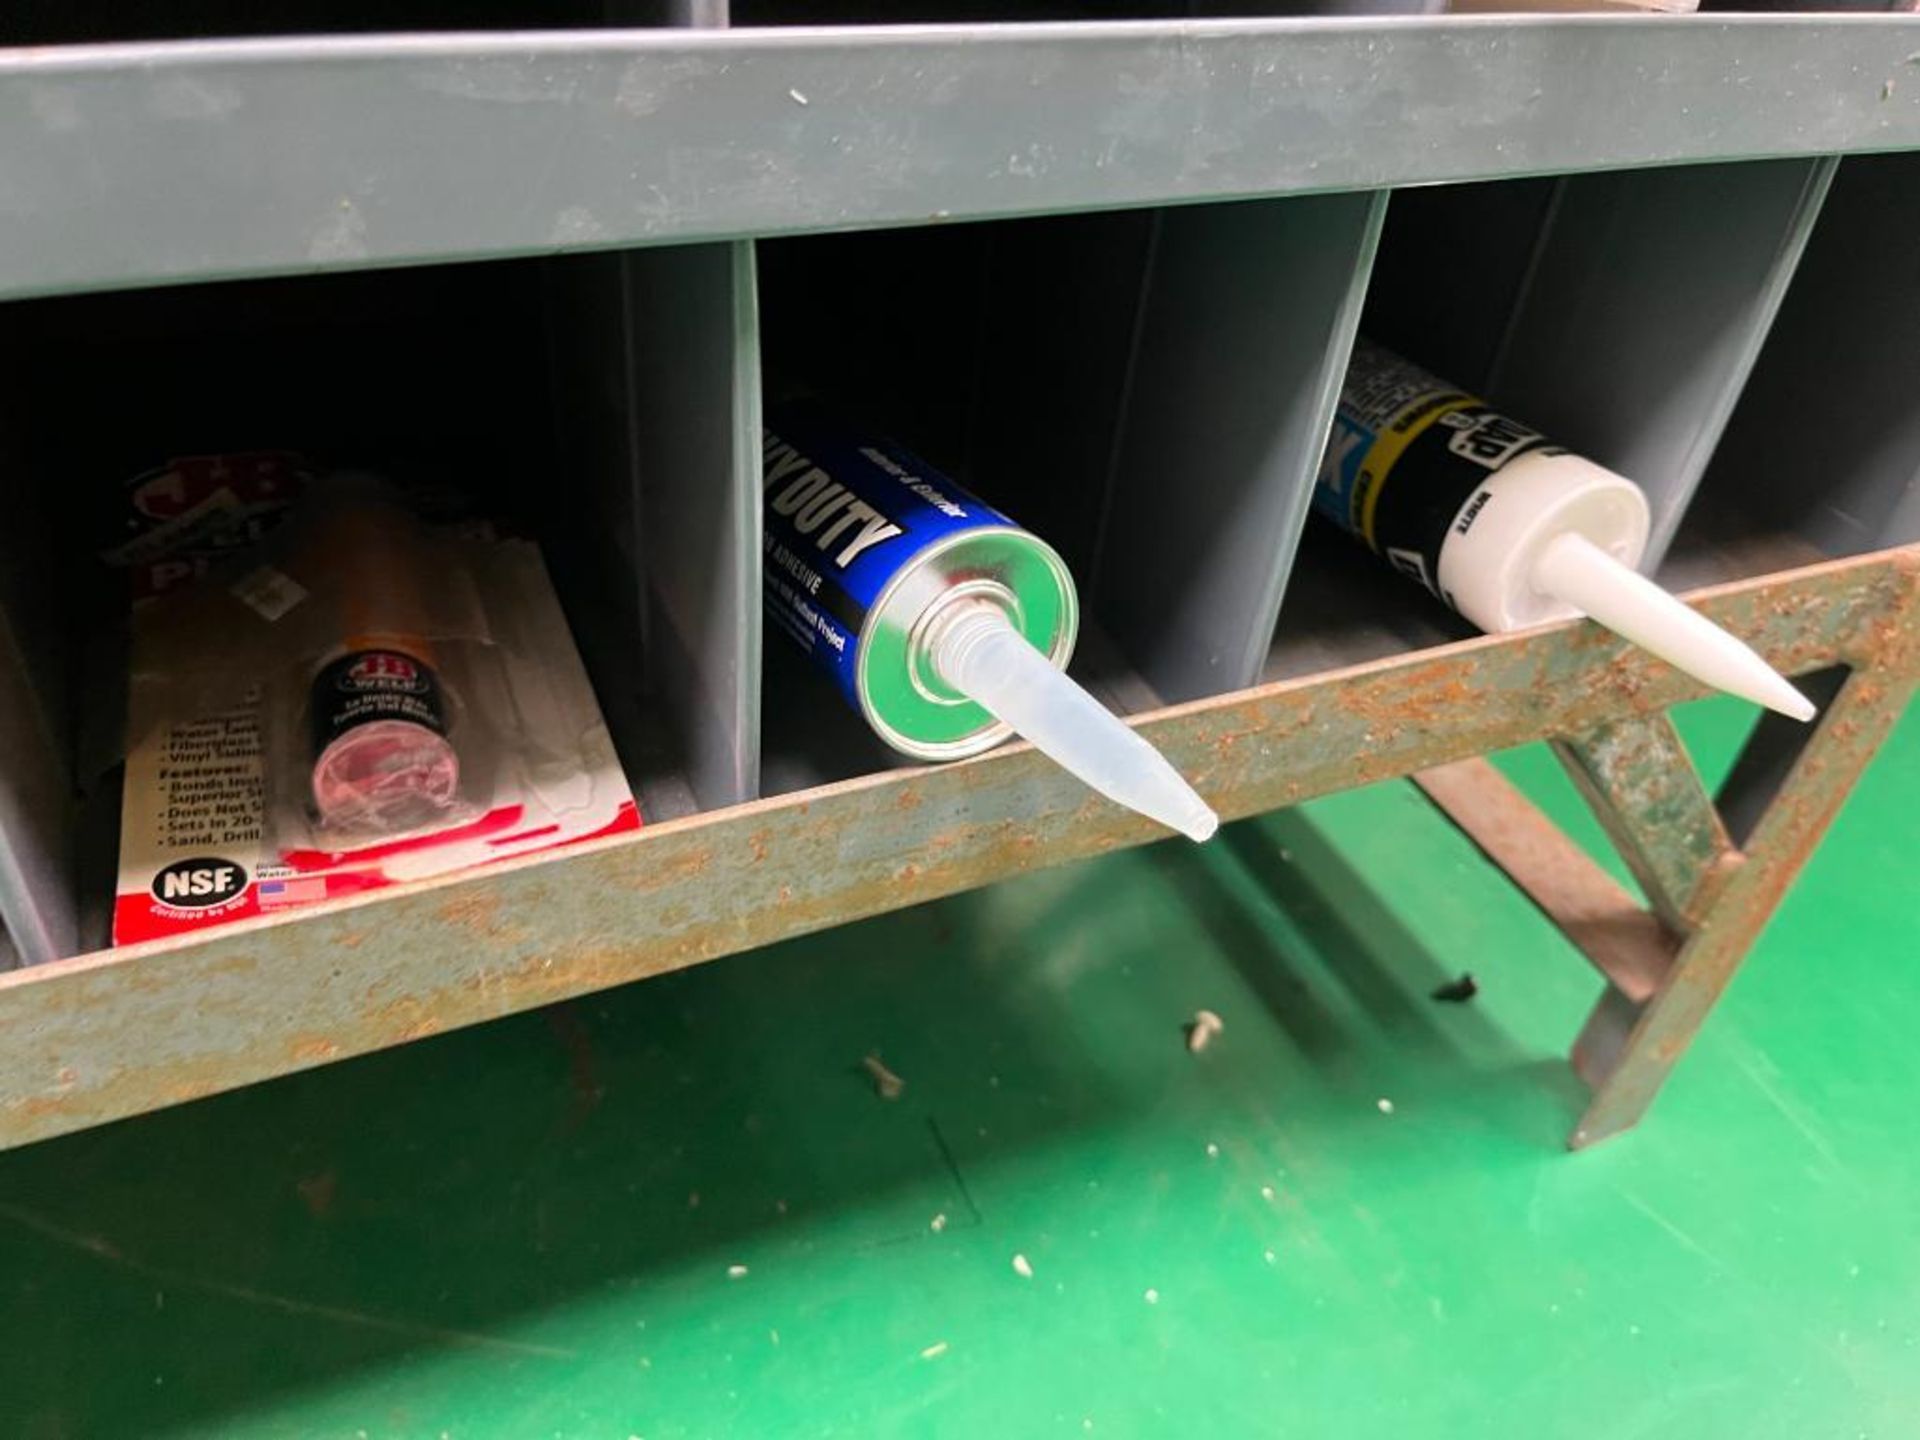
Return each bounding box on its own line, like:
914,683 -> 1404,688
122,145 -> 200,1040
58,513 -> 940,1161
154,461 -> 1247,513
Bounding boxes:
113,474 -> 639,945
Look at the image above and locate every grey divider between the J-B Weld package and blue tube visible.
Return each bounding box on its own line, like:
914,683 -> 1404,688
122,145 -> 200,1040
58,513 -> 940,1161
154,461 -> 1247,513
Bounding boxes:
553,242 -> 760,818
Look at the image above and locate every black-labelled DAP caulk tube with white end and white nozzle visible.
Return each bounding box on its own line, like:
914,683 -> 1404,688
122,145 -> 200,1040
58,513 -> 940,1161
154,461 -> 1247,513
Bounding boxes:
1313,340 -> 1814,720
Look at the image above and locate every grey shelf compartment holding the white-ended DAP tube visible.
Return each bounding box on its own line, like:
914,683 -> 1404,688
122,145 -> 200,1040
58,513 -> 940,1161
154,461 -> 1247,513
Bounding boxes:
1263,159 -> 1834,680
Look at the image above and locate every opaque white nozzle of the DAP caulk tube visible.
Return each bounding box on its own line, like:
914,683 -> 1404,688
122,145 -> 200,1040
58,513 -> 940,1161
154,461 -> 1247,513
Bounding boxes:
1532,534 -> 1814,720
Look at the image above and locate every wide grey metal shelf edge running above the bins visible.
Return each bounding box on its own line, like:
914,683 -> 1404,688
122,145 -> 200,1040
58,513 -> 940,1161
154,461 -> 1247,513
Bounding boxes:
0,15 -> 1920,298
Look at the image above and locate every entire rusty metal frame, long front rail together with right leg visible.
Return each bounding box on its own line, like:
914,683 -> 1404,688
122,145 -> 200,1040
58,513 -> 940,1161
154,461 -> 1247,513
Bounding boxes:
0,547 -> 1920,1144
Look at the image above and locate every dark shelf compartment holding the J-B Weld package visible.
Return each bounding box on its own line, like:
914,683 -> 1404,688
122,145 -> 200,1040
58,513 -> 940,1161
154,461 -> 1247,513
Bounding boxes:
0,244 -> 758,962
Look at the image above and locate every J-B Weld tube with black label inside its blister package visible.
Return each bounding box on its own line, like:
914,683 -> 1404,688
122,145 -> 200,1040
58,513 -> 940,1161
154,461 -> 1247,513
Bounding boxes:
305,476 -> 461,835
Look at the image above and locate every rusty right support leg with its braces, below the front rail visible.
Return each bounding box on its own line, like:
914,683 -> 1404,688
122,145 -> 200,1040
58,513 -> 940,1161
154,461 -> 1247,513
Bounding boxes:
1415,547 -> 1920,1150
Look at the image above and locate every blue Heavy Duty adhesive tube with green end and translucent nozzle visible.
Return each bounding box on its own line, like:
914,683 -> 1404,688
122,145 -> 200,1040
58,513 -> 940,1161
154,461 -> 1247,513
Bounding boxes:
762,403 -> 1219,841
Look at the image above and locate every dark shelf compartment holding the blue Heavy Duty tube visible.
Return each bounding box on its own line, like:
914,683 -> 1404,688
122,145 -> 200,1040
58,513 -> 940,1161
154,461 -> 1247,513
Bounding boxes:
760,194 -> 1384,793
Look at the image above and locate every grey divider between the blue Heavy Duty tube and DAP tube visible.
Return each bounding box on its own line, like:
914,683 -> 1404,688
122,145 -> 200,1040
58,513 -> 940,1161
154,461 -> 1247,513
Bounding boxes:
1092,192 -> 1386,701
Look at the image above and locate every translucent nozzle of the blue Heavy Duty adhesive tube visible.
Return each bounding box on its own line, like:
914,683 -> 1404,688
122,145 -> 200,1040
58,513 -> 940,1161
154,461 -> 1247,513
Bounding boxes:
929,601 -> 1219,841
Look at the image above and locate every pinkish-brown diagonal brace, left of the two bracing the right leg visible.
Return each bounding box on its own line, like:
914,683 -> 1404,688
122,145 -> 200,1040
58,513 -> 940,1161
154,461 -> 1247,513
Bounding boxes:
1413,758 -> 1674,1002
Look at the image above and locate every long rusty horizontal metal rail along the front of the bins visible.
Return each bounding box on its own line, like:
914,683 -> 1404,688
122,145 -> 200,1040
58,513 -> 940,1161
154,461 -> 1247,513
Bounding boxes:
0,553 -> 1899,1144
